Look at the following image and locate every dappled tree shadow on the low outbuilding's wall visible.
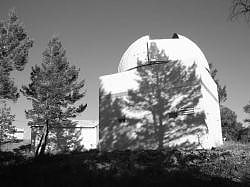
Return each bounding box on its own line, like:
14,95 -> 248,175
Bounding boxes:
31,120 -> 83,153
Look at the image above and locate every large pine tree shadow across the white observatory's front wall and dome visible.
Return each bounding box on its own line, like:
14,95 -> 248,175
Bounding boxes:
100,43 -> 208,150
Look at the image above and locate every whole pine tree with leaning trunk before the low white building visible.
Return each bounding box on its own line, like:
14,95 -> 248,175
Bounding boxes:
21,37 -> 87,156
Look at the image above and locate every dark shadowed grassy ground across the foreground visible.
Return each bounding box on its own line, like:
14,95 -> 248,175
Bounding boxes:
0,145 -> 250,186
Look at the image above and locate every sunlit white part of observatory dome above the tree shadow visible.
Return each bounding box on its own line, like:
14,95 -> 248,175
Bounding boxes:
118,33 -> 209,72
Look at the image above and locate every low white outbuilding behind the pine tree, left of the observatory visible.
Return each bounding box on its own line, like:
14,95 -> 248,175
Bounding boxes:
31,120 -> 99,153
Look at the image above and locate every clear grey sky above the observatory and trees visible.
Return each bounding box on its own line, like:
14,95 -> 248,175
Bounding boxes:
0,0 -> 250,137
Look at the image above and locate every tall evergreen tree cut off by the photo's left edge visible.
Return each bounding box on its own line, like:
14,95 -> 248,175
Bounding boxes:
0,10 -> 33,100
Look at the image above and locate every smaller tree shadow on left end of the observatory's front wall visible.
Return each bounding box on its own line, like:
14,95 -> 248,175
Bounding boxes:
99,87 -> 139,150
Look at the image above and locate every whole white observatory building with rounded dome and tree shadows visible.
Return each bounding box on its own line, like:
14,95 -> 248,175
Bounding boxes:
99,34 -> 222,150
